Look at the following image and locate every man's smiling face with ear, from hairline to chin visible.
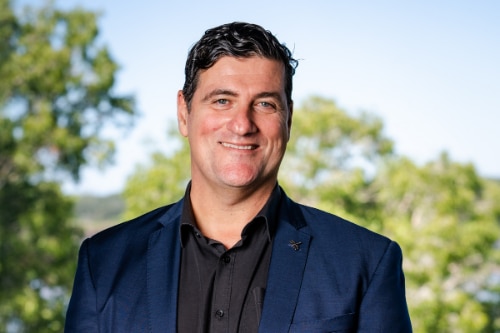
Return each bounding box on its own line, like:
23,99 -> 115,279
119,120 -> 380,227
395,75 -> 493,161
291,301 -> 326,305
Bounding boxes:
178,56 -> 292,192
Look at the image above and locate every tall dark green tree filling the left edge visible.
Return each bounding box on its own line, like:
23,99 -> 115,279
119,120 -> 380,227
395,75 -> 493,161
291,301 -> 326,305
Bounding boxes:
0,0 -> 134,332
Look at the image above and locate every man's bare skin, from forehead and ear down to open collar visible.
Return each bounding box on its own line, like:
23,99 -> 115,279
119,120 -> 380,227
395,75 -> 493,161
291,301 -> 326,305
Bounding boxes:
178,55 -> 292,249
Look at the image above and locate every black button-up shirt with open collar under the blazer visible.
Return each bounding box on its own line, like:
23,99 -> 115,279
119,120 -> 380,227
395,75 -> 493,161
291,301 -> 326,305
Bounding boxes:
177,186 -> 281,333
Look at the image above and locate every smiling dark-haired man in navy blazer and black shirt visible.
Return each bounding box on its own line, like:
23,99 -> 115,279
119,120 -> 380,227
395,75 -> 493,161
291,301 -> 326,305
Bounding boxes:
66,23 -> 411,333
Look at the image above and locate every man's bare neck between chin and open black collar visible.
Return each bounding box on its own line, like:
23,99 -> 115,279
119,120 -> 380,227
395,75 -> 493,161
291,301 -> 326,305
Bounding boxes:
190,182 -> 275,248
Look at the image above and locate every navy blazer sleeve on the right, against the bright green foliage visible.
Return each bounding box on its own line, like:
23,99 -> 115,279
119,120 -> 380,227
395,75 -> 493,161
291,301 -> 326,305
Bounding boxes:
358,242 -> 412,333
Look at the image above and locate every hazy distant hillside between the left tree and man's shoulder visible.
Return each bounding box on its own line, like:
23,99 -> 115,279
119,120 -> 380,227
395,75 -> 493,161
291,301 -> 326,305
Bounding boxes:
74,194 -> 125,236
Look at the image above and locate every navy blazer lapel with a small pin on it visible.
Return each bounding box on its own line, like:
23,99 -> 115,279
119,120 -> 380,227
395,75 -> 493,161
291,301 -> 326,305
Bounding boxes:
259,196 -> 311,333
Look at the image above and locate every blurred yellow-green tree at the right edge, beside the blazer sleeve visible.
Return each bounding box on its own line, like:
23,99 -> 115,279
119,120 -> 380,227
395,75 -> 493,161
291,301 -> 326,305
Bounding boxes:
374,154 -> 500,332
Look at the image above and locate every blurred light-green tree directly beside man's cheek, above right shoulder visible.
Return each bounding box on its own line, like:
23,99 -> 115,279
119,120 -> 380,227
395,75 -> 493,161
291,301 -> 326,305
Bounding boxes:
280,96 -> 393,229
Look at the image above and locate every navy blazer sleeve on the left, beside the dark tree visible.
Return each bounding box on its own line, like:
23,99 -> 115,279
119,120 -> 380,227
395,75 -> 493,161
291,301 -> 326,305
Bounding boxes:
64,239 -> 99,333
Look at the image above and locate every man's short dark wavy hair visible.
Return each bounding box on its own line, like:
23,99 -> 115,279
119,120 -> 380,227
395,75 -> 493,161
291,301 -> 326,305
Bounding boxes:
182,22 -> 298,109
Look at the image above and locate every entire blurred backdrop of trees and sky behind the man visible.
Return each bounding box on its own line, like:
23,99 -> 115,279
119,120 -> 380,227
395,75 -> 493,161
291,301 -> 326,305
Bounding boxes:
0,0 -> 500,332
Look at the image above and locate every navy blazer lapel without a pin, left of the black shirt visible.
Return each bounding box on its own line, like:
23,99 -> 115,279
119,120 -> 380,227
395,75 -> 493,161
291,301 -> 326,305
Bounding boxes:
147,201 -> 183,333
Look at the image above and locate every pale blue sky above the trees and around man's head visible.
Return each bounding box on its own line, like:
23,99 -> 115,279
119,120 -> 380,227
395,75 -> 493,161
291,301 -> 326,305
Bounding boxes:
18,0 -> 500,194
